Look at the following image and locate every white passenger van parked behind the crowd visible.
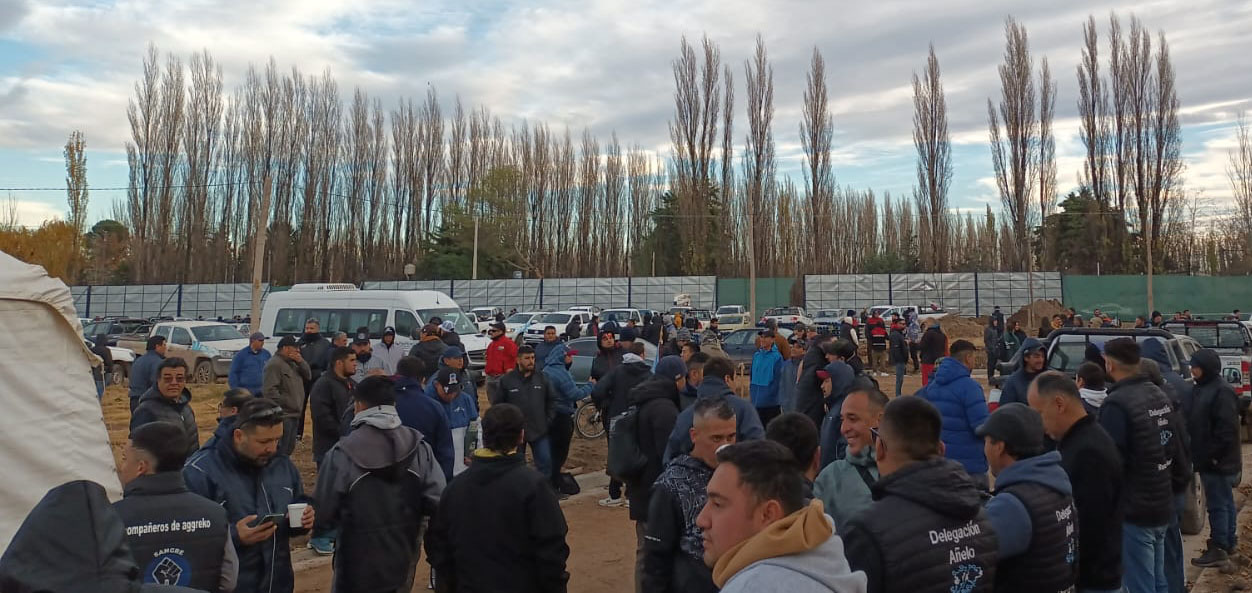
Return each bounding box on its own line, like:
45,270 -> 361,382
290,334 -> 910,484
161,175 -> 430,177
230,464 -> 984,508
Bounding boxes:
259,284 -> 487,370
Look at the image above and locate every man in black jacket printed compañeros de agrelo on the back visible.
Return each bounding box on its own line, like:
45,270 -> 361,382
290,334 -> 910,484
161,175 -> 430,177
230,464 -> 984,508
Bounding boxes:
113,422 -> 239,593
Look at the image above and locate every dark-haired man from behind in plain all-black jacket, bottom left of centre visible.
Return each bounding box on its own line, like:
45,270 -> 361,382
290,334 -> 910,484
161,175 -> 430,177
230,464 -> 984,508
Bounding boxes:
426,404 -> 570,593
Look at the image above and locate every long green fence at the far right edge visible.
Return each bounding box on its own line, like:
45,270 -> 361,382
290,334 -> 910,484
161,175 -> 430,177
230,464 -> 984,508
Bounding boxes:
1062,275 -> 1252,318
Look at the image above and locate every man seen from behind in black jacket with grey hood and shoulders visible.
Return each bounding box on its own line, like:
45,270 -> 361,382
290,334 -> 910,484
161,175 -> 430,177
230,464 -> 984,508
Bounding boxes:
314,377 -> 444,593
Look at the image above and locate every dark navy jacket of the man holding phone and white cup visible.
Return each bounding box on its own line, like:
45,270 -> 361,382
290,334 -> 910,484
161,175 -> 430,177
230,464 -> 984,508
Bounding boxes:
183,430 -> 312,593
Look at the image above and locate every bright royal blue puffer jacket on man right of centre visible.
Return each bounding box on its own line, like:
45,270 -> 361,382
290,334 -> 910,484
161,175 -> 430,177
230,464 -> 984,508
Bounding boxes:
918,358 -> 988,474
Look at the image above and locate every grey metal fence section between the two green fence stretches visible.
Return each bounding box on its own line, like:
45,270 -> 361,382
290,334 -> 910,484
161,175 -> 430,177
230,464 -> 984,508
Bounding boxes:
804,271 -> 1062,317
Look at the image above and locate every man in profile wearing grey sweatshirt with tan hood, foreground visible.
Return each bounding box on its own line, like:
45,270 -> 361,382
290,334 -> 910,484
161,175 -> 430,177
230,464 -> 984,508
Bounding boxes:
696,440 -> 865,593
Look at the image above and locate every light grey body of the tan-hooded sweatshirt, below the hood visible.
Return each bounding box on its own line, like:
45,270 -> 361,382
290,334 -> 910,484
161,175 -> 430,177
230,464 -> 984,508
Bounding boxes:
721,534 -> 865,593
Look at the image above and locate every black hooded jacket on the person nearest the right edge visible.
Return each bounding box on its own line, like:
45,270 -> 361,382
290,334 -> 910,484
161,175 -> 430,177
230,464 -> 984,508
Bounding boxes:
1188,348 -> 1243,475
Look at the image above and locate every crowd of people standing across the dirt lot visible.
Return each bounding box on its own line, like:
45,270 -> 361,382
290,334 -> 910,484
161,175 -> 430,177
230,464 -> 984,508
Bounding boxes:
0,305 -> 1242,593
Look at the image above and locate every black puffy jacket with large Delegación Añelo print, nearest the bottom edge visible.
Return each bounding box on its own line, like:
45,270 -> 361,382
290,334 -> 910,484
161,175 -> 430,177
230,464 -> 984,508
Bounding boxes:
844,458 -> 999,593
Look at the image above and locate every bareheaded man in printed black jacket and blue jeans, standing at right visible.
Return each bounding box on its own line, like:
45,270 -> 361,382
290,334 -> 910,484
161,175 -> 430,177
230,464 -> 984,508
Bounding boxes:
1099,338 -> 1182,592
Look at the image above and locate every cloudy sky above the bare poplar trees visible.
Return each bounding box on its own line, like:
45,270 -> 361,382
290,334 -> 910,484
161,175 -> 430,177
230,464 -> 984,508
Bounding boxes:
0,0 -> 1252,224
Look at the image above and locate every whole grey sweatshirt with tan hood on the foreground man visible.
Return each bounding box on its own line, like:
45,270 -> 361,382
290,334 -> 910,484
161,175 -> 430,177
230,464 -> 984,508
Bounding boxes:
712,500 -> 865,593
